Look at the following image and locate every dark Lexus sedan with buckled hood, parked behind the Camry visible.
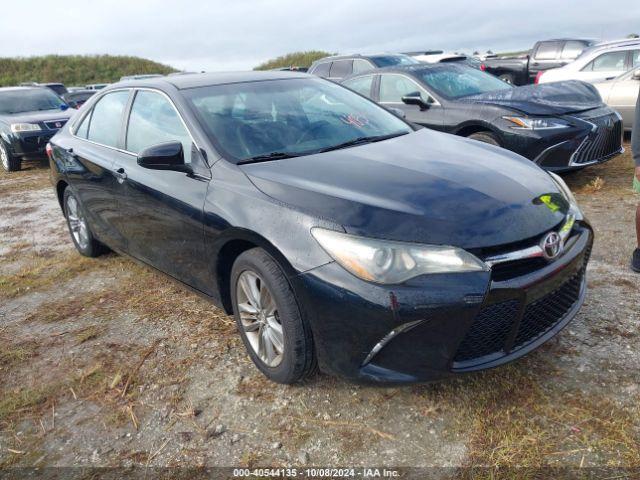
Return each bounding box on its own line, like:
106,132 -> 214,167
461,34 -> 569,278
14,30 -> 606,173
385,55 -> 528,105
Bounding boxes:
343,63 -> 623,171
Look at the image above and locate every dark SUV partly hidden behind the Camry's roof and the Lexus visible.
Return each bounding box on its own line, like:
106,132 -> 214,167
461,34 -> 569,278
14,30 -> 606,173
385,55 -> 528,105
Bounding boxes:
309,53 -> 420,80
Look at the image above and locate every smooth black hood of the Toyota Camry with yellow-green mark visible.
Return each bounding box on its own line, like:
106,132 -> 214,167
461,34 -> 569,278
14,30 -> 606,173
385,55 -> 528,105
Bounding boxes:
241,129 -> 568,249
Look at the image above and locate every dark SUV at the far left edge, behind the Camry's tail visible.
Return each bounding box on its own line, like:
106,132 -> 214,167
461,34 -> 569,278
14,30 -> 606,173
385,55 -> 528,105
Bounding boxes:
0,87 -> 71,172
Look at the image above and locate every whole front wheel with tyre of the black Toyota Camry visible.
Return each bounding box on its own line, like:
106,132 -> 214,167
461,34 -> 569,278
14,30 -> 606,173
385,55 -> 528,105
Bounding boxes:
231,248 -> 316,384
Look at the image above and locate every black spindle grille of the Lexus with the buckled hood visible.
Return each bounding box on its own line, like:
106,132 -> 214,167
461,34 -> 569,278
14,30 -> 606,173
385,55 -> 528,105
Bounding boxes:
571,115 -> 622,165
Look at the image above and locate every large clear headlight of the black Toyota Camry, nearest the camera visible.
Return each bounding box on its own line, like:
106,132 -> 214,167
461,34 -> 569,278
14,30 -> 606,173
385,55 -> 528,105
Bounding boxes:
311,228 -> 489,284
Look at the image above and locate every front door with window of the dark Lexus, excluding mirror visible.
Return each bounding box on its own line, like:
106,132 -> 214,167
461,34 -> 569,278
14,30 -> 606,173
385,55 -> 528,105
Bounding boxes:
377,73 -> 444,130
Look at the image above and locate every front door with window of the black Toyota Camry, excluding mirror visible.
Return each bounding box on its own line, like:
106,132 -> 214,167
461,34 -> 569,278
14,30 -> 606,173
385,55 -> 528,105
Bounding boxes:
116,89 -> 211,293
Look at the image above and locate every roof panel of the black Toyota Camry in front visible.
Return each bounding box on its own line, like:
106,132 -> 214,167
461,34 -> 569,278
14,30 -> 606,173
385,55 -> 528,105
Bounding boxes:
112,70 -> 318,90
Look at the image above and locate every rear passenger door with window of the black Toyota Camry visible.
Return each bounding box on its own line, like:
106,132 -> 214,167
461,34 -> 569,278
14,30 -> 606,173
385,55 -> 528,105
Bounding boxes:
65,89 -> 131,251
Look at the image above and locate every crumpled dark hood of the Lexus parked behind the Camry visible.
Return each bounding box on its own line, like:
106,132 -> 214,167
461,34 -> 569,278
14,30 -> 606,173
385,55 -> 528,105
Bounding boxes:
462,80 -> 604,115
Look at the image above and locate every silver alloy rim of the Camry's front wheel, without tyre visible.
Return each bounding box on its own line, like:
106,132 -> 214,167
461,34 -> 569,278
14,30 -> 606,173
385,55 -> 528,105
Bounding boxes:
236,270 -> 284,368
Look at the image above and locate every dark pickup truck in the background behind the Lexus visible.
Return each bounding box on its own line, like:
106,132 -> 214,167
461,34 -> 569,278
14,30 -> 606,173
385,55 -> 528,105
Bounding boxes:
481,38 -> 596,85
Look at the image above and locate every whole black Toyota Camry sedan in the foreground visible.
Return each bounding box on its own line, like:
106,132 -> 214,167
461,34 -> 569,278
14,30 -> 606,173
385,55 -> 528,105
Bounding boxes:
49,72 -> 593,383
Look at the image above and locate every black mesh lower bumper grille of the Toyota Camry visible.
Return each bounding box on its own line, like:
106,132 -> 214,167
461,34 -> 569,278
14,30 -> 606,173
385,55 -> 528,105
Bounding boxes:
454,266 -> 588,362
